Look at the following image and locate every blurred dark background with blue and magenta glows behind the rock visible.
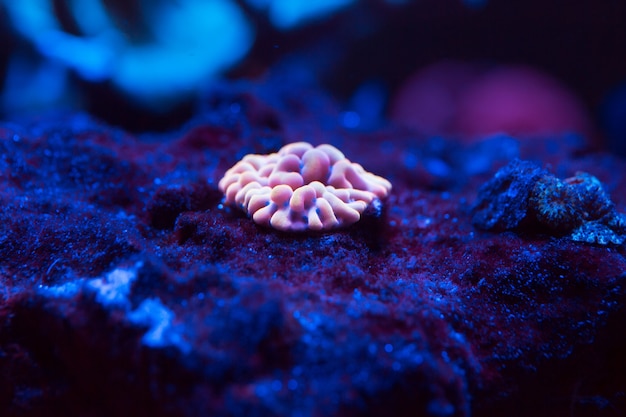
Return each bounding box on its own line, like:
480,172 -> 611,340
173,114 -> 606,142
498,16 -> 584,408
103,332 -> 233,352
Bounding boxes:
0,0 -> 626,156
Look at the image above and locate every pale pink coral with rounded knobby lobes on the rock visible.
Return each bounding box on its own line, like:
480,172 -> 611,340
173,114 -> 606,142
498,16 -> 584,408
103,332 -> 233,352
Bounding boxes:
219,142 -> 391,231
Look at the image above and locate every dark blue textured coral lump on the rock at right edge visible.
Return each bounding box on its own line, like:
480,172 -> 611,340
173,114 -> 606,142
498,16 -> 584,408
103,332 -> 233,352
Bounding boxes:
473,160 -> 626,245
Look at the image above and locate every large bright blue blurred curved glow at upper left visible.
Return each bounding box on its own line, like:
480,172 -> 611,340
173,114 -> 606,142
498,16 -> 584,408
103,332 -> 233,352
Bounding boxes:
0,0 -> 254,108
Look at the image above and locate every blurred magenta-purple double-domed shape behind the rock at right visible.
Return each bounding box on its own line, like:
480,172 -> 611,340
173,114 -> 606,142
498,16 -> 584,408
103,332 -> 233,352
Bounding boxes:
391,62 -> 592,141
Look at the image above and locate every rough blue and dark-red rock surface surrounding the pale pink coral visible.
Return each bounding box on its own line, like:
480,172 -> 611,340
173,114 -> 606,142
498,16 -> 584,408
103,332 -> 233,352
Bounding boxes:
0,79 -> 626,417
